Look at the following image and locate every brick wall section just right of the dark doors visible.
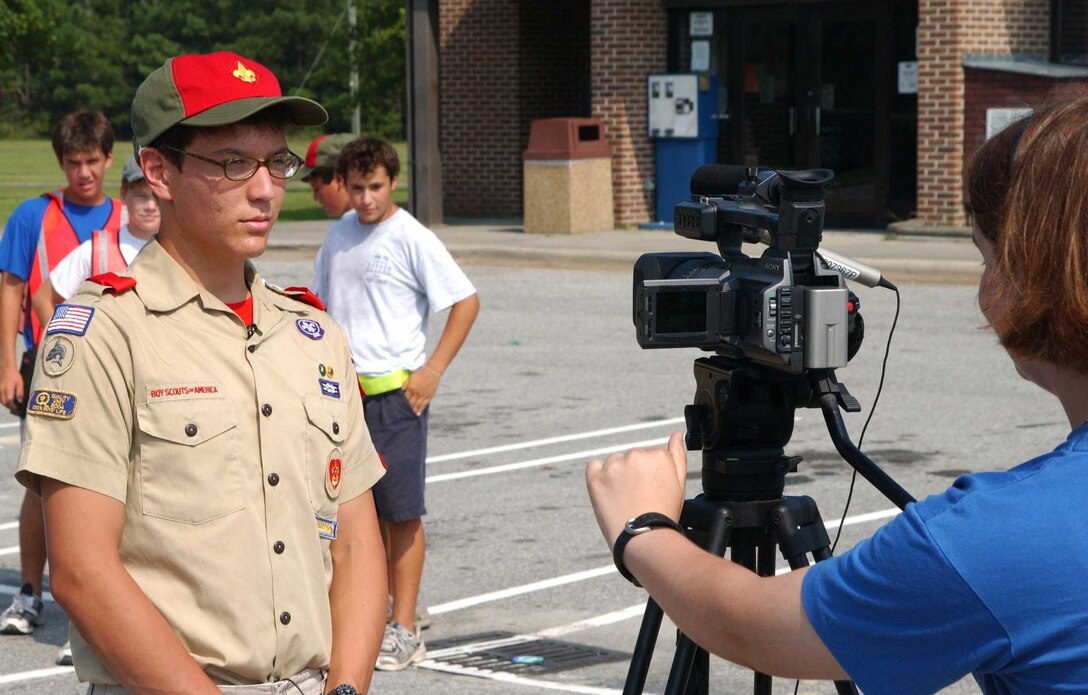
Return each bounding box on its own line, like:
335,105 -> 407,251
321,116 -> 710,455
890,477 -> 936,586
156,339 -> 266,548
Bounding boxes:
917,0 -> 1050,226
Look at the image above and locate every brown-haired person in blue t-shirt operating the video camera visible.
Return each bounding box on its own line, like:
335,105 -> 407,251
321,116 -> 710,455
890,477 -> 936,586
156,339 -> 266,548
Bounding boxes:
586,97 -> 1088,695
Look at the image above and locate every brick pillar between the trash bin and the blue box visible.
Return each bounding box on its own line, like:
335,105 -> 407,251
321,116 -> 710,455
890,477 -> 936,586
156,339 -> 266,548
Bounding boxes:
590,0 -> 668,227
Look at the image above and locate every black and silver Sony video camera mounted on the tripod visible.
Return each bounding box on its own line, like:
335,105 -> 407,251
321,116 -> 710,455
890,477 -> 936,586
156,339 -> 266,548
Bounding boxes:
633,164 -> 883,374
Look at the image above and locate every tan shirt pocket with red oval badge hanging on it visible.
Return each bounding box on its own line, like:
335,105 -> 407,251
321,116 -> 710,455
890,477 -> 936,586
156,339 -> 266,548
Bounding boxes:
302,396 -> 348,519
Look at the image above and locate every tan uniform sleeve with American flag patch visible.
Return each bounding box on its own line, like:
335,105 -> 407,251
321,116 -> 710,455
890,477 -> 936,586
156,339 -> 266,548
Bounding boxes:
15,305 -> 133,502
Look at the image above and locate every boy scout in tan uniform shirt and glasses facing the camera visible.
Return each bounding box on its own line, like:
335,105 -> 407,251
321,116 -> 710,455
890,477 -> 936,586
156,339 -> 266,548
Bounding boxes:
16,53 -> 386,695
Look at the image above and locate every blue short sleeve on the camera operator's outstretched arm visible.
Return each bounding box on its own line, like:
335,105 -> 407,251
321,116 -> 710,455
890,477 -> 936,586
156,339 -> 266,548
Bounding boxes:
802,505 -> 1012,695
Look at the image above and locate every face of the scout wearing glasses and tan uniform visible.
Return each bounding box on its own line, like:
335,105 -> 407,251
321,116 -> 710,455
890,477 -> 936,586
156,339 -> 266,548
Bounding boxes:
153,124 -> 288,263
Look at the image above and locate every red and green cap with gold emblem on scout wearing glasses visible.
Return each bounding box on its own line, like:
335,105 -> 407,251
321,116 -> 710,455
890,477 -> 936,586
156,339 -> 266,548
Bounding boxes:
132,51 -> 329,149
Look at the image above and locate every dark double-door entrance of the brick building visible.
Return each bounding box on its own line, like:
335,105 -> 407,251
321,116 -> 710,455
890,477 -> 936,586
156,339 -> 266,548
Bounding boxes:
718,1 -> 914,227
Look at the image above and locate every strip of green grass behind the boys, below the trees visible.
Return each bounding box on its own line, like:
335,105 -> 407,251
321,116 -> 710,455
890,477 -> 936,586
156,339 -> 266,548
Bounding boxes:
0,138 -> 408,224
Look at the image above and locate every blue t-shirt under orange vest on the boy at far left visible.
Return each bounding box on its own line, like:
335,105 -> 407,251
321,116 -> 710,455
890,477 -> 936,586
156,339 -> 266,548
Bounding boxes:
0,196 -> 112,346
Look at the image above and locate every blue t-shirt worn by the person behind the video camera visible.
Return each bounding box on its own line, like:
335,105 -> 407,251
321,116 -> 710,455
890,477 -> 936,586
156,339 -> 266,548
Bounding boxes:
802,426 -> 1088,695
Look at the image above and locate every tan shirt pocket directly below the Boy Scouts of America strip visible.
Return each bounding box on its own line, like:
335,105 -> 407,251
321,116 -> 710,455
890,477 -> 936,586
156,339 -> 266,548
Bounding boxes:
136,398 -> 246,524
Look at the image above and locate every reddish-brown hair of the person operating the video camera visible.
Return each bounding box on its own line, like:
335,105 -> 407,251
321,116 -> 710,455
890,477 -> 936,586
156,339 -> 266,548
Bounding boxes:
965,96 -> 1088,372
